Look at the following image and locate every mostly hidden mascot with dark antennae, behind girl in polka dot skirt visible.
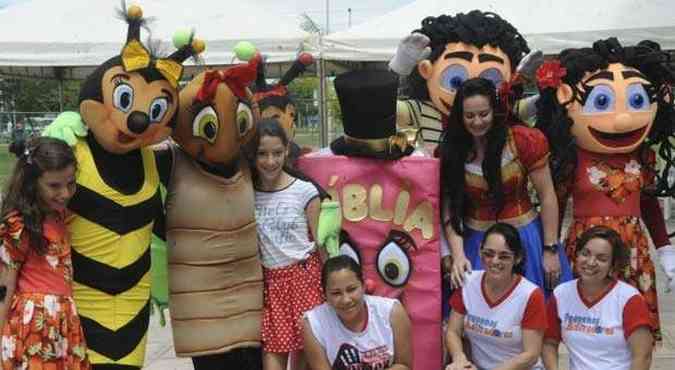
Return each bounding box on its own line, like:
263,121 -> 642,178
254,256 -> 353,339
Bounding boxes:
254,53 -> 314,164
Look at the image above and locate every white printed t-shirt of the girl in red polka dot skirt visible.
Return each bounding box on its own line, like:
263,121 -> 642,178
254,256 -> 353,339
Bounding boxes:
255,179 -> 319,268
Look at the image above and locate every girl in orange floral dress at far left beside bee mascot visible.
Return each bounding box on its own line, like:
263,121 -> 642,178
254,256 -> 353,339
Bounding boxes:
0,137 -> 90,370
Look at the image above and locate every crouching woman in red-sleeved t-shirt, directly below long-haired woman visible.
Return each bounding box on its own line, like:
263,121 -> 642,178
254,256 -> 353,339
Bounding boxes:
446,223 -> 546,370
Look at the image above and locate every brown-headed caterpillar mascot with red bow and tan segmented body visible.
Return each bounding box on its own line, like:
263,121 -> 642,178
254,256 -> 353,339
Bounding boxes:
156,55 -> 263,370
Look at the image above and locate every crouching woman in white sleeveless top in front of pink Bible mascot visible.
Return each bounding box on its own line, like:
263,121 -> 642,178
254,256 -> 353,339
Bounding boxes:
302,255 -> 413,370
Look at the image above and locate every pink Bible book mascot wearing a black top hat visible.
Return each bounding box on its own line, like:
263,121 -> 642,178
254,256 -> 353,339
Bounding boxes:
298,71 -> 442,369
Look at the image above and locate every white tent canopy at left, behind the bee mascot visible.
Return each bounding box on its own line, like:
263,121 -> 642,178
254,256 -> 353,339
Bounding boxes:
0,0 -> 308,79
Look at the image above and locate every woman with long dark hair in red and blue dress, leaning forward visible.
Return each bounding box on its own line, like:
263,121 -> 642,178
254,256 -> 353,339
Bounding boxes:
441,78 -> 572,291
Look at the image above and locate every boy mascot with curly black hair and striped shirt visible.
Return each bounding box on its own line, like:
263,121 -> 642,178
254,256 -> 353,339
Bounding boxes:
389,10 -> 531,150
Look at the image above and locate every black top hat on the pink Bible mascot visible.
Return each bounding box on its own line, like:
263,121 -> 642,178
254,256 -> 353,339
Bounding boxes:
330,71 -> 414,159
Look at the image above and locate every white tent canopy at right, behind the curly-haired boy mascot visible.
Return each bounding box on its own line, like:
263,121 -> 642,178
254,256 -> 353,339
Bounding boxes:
322,0 -> 675,62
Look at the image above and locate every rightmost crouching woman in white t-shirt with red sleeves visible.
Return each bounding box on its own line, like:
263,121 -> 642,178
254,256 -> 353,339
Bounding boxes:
543,226 -> 654,370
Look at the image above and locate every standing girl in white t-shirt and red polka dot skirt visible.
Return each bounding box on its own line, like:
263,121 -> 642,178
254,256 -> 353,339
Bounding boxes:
249,119 -> 324,370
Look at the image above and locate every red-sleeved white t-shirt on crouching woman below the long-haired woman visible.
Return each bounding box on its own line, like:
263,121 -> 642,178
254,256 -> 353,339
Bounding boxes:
450,271 -> 546,369
